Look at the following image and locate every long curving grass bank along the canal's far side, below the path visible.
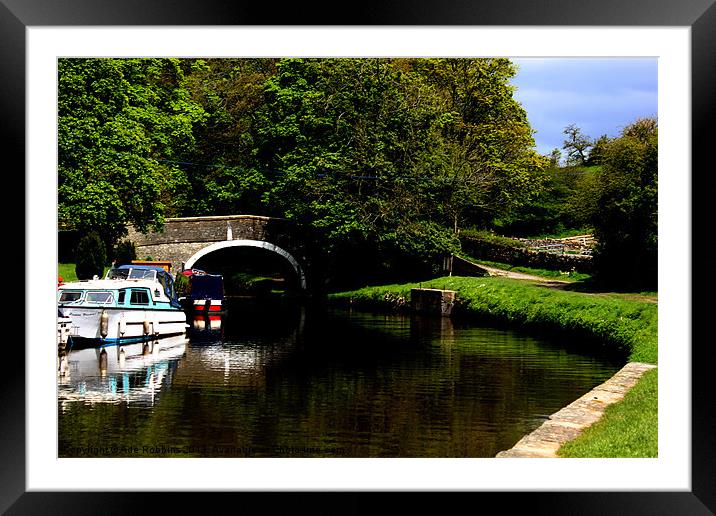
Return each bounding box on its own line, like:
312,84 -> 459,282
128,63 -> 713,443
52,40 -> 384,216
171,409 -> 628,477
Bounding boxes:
329,276 -> 658,364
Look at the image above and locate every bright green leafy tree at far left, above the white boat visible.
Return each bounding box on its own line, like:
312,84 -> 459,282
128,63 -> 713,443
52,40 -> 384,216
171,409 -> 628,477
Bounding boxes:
58,58 -> 204,248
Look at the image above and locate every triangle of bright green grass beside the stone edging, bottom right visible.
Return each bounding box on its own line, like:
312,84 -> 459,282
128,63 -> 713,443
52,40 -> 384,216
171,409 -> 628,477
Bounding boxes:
557,369 -> 659,458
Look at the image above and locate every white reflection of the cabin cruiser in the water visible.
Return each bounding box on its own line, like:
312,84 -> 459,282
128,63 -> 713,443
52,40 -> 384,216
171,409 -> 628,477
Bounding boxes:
57,335 -> 188,407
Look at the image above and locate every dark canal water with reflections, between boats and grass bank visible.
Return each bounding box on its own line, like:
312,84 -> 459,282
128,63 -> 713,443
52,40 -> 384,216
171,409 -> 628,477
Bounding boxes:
58,301 -> 624,458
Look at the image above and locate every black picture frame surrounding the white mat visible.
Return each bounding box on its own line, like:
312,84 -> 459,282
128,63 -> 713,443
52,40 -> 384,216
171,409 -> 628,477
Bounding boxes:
0,0 -> 716,515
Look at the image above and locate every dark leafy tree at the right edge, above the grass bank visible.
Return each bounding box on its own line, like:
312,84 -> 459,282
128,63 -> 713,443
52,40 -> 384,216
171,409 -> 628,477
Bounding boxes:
593,118 -> 658,288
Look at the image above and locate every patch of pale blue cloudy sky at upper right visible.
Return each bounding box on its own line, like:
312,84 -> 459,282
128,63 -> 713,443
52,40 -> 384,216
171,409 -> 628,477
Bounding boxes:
511,58 -> 658,154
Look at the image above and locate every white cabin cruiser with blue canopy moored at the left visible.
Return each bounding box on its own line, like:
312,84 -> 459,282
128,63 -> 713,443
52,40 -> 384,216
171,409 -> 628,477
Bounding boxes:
57,264 -> 187,349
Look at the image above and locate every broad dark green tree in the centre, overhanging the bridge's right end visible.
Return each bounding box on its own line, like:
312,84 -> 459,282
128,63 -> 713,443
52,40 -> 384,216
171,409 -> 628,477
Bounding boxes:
258,59 -> 462,282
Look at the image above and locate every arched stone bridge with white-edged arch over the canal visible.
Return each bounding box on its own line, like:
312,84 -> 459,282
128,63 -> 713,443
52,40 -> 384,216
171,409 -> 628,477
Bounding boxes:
127,215 -> 307,289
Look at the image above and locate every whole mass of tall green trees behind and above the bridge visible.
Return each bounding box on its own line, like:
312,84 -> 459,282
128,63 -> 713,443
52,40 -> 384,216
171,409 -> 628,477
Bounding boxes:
58,58 -> 548,286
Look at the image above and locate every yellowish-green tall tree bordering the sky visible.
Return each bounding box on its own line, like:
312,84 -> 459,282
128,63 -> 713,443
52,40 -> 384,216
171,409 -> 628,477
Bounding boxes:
413,58 -> 548,231
